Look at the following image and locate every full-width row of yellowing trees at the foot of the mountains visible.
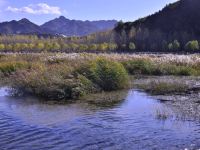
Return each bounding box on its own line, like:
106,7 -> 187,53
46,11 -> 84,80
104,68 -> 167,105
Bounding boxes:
0,33 -> 200,52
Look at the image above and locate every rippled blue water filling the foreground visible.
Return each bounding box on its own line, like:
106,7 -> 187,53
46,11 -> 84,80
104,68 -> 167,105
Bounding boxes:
0,89 -> 200,150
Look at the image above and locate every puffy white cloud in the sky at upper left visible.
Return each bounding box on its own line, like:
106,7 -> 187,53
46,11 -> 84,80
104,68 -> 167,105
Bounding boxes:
6,3 -> 62,15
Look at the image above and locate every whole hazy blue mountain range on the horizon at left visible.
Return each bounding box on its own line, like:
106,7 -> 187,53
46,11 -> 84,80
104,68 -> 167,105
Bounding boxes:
0,16 -> 117,36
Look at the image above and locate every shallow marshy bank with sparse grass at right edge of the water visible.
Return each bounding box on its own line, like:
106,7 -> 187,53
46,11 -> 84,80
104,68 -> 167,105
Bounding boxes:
134,76 -> 200,121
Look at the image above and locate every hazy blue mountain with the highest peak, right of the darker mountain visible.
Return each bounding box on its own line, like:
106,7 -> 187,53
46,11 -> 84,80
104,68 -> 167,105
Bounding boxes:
41,16 -> 117,36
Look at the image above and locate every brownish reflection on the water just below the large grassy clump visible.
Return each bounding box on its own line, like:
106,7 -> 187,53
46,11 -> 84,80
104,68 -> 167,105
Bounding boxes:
0,88 -> 127,126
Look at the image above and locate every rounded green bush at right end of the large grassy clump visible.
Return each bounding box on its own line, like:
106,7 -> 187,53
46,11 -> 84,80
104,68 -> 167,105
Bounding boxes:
82,58 -> 129,91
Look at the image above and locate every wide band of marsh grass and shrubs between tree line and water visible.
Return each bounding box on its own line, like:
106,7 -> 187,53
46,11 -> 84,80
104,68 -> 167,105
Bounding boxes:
0,53 -> 200,100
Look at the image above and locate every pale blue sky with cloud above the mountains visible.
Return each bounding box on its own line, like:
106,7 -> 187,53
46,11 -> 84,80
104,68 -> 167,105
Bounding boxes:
0,0 -> 177,25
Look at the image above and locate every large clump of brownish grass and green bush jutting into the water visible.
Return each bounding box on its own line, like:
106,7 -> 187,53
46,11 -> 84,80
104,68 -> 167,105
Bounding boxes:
5,55 -> 128,100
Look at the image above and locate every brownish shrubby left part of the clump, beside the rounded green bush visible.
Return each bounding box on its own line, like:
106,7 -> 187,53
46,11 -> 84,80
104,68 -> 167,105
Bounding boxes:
11,66 -> 80,100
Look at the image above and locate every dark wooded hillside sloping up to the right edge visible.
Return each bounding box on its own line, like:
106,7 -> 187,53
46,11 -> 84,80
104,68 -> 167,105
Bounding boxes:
114,0 -> 200,51
